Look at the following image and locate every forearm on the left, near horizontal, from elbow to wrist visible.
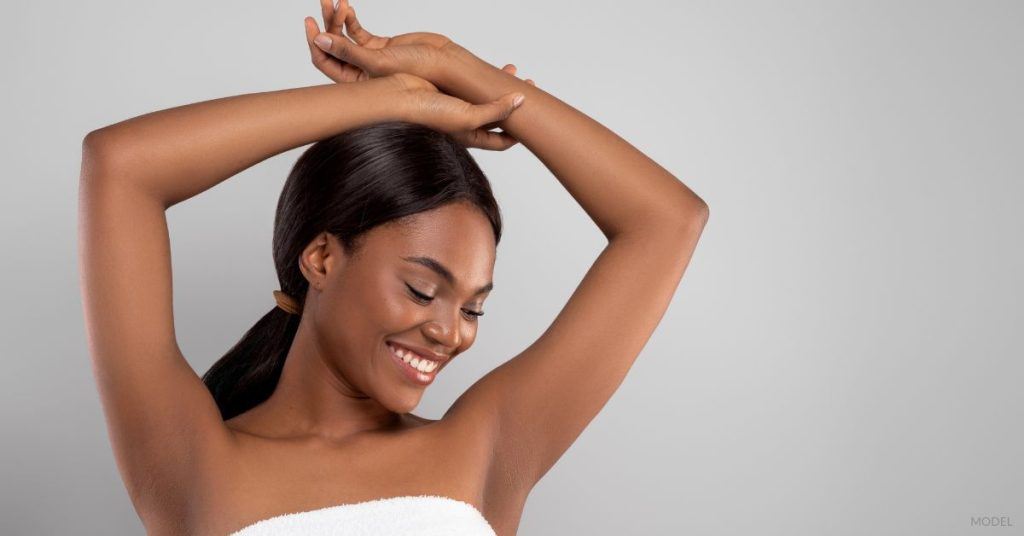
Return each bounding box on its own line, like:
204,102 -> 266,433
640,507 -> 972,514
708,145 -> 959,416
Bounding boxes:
83,80 -> 400,207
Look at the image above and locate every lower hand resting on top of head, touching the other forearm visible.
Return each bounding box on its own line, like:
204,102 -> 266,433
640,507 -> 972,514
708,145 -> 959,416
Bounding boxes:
379,73 -> 525,151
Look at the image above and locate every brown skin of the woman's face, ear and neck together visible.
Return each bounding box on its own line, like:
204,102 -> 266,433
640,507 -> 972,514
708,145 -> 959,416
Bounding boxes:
227,203 -> 496,443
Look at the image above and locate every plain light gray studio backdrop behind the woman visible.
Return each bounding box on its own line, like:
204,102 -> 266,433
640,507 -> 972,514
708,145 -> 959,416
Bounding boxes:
0,0 -> 1024,535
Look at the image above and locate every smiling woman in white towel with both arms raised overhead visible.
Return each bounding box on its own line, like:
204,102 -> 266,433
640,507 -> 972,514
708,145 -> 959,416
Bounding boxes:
80,2 -> 708,536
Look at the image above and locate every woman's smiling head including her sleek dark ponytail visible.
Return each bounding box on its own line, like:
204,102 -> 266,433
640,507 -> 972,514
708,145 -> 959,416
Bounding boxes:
203,122 -> 502,419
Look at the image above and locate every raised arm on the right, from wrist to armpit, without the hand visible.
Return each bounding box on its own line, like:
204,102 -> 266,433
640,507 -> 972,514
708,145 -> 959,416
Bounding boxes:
438,49 -> 709,489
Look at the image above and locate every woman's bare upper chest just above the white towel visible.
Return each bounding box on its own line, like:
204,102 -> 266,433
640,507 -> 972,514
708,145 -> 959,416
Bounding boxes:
177,426 -> 522,535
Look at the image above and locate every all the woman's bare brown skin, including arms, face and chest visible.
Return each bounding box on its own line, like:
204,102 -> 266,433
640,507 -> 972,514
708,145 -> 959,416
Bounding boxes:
79,4 -> 709,536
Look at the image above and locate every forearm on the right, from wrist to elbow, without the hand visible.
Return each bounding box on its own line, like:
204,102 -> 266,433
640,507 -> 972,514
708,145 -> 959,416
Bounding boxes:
440,47 -> 708,239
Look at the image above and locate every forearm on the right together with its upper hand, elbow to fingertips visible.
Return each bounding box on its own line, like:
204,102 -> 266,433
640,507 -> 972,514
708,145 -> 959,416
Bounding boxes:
306,16 -> 708,232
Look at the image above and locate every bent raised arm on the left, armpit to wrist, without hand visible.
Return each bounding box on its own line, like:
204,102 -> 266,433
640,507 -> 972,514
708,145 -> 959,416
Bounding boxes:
79,80 -> 400,533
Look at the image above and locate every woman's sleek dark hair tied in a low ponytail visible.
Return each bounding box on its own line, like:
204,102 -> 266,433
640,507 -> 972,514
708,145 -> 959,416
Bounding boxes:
203,121 -> 502,420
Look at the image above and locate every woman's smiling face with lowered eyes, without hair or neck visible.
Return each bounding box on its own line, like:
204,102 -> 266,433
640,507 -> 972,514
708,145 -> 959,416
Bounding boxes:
304,202 -> 496,413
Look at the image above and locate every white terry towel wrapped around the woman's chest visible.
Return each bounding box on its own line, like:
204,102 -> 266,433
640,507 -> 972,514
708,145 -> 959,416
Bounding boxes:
231,495 -> 497,536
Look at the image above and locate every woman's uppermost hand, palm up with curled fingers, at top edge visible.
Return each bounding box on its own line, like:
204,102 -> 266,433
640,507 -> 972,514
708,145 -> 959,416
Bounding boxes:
304,0 -> 537,86
